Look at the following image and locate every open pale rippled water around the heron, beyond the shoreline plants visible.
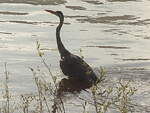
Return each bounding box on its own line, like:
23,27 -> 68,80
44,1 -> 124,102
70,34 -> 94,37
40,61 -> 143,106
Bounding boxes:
0,0 -> 150,111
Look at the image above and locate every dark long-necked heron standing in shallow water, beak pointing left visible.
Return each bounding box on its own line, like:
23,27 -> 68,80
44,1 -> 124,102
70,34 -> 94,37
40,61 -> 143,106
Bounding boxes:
45,10 -> 98,83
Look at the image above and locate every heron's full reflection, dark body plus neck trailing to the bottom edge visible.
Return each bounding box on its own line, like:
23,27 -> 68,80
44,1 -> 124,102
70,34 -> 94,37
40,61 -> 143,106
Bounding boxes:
52,77 -> 93,113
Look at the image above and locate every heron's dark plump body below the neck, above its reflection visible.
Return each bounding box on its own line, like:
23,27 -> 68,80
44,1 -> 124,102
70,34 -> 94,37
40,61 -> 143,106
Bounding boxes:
60,54 -> 96,81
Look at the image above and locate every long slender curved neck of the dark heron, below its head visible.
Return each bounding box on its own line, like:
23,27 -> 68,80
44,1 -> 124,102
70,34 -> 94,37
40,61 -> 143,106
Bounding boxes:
56,17 -> 69,58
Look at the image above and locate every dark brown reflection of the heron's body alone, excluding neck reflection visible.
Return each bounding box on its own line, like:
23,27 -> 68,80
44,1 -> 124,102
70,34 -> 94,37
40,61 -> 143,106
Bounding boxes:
57,78 -> 92,96
